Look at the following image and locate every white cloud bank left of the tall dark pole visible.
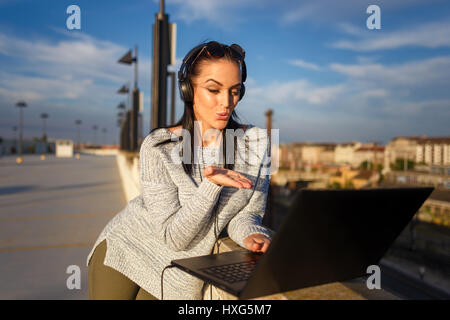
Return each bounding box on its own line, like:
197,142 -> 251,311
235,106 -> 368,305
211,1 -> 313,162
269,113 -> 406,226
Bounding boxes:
0,31 -> 151,105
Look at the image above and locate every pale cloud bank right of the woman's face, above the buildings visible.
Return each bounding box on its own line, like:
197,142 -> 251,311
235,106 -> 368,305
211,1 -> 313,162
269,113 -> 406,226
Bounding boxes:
238,56 -> 450,142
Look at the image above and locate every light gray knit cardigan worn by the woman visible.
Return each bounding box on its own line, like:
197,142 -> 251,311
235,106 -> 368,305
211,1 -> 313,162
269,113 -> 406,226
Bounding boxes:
87,125 -> 271,299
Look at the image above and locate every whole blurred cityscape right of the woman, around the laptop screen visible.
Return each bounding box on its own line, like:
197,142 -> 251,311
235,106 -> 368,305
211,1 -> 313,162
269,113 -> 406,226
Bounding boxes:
265,136 -> 450,296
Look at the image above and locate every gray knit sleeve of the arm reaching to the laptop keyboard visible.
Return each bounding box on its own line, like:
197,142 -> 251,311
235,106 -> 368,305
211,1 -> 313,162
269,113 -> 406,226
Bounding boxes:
227,128 -> 272,248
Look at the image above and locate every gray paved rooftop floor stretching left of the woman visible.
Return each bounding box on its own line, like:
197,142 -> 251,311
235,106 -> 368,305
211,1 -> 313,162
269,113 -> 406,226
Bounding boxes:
0,155 -> 126,299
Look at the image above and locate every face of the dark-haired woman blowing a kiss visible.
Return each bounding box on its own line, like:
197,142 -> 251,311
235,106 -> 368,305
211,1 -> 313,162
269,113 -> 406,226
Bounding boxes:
192,59 -> 241,134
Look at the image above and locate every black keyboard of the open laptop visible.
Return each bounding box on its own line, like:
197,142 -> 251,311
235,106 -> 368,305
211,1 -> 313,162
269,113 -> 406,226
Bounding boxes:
200,260 -> 256,283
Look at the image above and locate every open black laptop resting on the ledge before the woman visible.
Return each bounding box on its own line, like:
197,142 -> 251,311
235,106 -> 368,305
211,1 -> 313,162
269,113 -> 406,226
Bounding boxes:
172,187 -> 433,299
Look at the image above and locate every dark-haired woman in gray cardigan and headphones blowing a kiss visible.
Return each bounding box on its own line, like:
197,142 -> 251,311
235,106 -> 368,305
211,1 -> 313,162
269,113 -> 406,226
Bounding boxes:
87,41 -> 271,299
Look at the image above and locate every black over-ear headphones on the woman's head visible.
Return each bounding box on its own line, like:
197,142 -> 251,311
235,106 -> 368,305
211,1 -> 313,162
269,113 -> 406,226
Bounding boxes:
178,43 -> 247,102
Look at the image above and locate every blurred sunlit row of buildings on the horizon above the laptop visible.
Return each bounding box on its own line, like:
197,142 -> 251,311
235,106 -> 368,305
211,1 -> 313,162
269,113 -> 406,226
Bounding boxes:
279,137 -> 450,188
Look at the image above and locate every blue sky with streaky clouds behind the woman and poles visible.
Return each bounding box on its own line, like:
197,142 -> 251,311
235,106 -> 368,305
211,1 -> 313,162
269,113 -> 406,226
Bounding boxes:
0,0 -> 450,143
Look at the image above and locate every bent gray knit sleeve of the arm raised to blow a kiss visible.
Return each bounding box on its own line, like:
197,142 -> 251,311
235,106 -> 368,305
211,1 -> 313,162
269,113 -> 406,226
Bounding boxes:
140,137 -> 223,251
